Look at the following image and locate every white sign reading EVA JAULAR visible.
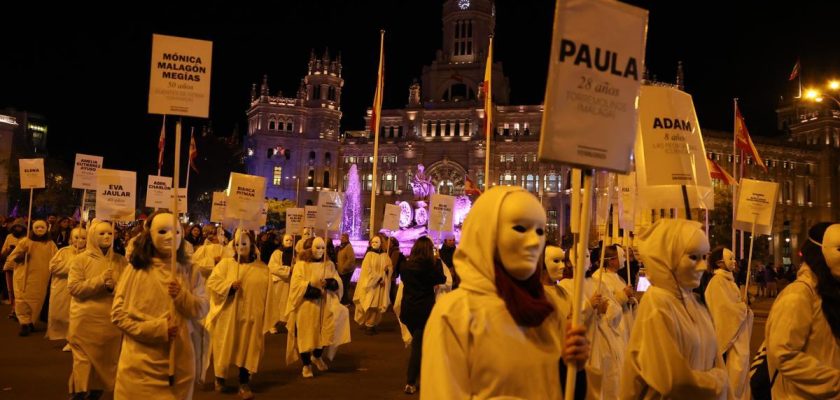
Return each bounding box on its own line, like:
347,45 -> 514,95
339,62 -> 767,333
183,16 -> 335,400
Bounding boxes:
96,168 -> 137,222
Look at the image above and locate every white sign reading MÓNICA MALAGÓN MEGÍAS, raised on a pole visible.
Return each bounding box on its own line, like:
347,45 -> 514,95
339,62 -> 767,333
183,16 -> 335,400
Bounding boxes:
149,34 -> 213,118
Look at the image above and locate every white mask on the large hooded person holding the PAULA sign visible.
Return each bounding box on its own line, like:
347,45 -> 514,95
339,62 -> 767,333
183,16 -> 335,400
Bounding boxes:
496,192 -> 545,281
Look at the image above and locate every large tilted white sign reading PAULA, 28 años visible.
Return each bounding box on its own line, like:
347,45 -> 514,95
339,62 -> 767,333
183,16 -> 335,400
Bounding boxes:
539,0 -> 648,172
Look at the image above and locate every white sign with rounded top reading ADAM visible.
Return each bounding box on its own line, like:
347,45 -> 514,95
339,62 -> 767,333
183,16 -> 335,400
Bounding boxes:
635,86 -> 715,210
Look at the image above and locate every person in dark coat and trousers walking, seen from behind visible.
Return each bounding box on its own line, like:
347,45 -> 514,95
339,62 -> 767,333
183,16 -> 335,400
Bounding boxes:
400,236 -> 446,394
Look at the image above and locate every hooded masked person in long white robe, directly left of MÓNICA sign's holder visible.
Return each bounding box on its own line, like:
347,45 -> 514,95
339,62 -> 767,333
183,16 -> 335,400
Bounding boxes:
67,221 -> 127,399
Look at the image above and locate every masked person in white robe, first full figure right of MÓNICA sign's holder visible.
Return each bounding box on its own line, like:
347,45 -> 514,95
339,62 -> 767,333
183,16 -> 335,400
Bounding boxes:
205,230 -> 276,399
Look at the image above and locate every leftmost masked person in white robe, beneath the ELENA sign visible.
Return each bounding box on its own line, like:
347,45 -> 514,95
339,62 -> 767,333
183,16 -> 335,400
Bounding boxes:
3,219 -> 58,336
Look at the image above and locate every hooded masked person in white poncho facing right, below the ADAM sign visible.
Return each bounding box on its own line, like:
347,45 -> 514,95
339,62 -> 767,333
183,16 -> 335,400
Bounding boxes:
621,219 -> 732,400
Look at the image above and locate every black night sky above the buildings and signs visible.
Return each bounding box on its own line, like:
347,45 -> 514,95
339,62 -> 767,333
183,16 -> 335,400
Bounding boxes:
0,0 -> 840,176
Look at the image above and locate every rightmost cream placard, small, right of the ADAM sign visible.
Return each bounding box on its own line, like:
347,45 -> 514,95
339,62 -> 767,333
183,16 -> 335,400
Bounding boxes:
735,178 -> 779,235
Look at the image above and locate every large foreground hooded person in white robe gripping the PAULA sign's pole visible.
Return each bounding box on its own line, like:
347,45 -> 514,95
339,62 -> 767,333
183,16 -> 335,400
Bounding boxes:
419,186 -> 588,400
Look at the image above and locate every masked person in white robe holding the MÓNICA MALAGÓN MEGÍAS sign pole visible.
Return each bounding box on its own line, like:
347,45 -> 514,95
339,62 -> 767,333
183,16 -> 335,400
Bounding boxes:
111,212 -> 209,400
